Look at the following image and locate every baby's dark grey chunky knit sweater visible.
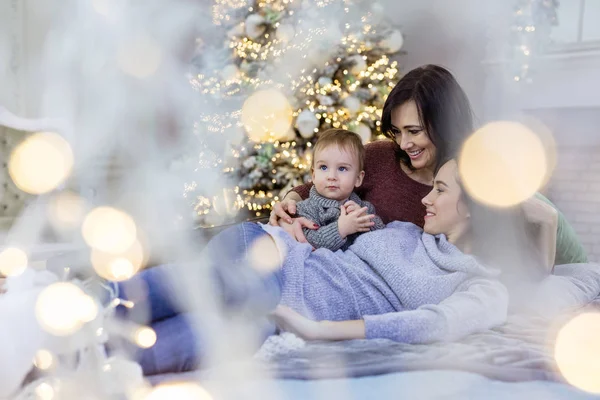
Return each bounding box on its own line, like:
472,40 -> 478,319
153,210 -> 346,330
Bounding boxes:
296,186 -> 385,251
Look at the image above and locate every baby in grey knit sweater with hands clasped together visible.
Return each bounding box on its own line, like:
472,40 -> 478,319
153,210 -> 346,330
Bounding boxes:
296,129 -> 385,251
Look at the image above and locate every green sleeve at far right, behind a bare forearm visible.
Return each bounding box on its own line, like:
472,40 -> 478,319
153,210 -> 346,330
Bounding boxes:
535,193 -> 588,265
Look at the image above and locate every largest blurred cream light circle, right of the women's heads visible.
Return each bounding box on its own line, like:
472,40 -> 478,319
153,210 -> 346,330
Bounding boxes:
458,122 -> 548,207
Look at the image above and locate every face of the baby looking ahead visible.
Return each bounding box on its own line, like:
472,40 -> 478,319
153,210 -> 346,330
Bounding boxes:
312,145 -> 364,201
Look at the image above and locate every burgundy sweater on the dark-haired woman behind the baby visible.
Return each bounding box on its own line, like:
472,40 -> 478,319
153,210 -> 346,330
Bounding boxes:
292,140 -> 432,227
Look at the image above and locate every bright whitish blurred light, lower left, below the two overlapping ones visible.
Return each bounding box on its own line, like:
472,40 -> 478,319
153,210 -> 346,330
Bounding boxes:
35,282 -> 98,336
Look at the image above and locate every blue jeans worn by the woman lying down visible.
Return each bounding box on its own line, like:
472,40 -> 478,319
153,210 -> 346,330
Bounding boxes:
119,222 -> 281,375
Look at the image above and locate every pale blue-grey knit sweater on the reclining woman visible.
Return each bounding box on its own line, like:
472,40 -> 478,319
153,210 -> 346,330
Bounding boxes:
263,222 -> 508,343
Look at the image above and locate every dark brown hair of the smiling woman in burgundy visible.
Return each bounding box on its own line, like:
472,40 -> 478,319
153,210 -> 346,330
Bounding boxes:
381,65 -> 473,169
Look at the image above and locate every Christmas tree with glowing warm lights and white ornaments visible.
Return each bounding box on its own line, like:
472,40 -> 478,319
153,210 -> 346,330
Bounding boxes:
185,0 -> 403,226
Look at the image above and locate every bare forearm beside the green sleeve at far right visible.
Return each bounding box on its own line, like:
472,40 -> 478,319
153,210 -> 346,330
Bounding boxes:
522,197 -> 558,272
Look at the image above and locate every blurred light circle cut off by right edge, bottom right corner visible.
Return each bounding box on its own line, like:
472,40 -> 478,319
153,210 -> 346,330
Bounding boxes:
554,313 -> 600,394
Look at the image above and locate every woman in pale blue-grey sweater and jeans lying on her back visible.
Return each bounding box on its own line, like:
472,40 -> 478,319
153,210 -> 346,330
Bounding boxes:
120,160 -> 508,374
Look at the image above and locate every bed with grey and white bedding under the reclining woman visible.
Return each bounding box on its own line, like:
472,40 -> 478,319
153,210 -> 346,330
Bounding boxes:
151,264 -> 600,400
